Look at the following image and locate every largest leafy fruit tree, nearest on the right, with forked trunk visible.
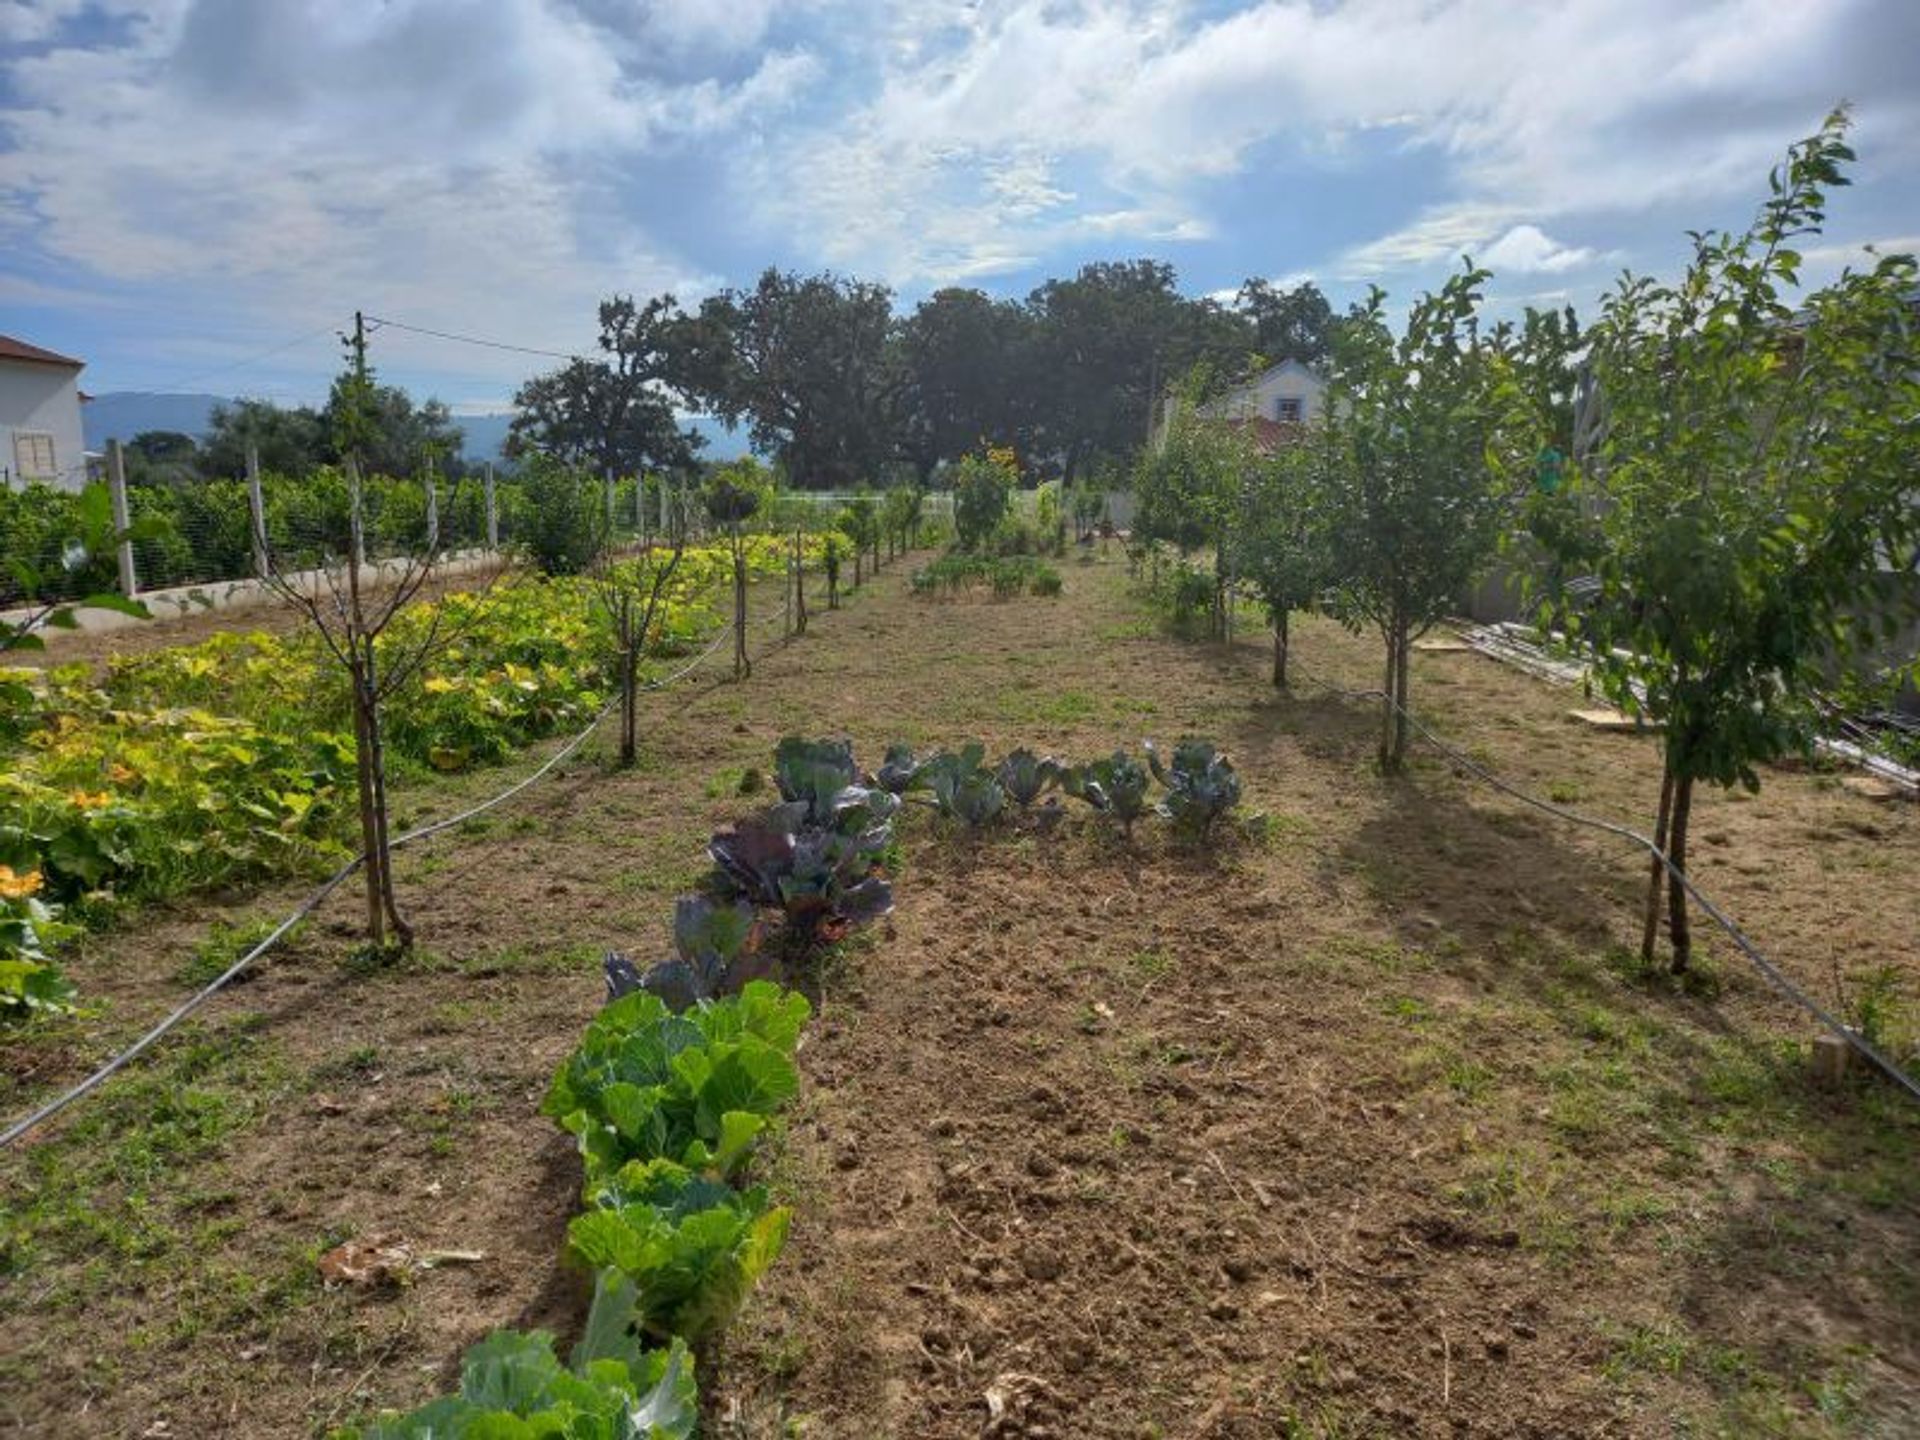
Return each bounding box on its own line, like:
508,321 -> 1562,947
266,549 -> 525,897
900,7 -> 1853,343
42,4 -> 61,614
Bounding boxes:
1530,111 -> 1920,972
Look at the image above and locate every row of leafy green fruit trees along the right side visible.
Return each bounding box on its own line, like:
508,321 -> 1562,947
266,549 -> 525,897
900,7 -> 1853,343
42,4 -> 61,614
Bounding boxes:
1121,113 -> 1920,972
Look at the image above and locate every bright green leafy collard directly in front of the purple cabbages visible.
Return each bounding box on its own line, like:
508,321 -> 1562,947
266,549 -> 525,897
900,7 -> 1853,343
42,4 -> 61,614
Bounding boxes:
541,981 -> 810,1194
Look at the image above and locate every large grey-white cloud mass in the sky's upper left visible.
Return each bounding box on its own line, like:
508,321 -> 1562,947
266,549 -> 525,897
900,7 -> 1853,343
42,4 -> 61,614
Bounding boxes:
0,0 -> 816,389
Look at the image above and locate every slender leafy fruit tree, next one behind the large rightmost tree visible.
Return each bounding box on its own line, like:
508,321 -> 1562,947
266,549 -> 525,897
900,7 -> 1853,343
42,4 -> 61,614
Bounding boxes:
1309,263 -> 1534,772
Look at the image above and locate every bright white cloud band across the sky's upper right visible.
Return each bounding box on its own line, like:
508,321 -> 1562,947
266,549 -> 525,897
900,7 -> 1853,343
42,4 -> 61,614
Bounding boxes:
739,0 -> 1920,282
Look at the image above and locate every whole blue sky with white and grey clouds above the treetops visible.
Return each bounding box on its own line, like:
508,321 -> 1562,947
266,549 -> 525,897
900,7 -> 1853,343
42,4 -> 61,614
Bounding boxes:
0,0 -> 1920,409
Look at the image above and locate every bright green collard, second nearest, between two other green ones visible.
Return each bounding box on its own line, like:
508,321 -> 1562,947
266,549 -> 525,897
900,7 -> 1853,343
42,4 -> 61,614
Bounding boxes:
566,1160 -> 793,1344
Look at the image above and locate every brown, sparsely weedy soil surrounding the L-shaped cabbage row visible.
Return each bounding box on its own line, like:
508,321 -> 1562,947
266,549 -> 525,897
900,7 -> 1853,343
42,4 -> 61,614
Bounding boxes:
0,561 -> 1920,1440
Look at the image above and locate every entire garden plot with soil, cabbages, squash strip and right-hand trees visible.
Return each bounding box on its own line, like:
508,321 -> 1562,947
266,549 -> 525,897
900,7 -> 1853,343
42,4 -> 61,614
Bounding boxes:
0,112 -> 1920,1440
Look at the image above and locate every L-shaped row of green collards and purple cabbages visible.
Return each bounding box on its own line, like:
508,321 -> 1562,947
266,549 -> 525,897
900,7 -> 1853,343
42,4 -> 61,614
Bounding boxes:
344,737 -> 1240,1440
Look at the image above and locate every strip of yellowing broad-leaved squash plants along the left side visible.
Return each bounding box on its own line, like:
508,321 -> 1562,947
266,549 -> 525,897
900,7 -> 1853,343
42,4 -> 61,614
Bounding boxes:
0,538 -> 818,1018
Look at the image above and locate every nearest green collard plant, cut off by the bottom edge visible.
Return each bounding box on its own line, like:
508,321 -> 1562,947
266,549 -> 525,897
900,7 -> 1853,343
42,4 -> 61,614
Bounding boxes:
334,1271 -> 699,1440
